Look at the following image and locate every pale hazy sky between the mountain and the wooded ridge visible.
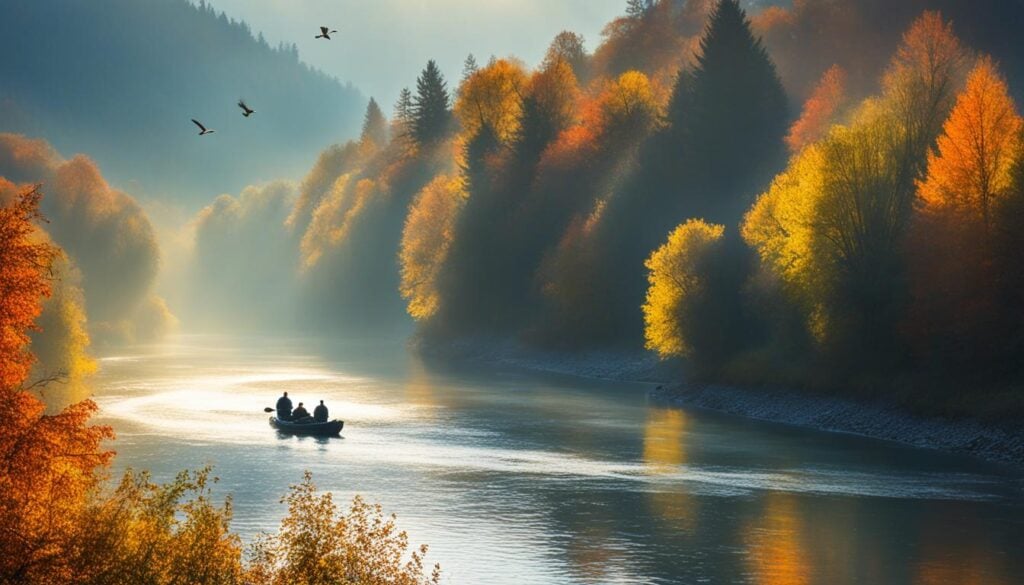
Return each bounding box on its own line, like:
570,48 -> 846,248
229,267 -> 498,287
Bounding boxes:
202,0 -> 626,107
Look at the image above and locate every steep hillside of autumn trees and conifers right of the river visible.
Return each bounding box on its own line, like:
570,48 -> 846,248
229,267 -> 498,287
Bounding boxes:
184,0 -> 1024,413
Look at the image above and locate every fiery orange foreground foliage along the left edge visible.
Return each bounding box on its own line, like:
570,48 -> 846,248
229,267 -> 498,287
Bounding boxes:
0,189 -> 112,583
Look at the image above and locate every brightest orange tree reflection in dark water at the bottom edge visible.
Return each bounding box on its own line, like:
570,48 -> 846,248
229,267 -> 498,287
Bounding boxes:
743,492 -> 811,585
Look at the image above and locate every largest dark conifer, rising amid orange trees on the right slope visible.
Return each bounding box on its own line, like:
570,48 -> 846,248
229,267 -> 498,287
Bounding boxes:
684,0 -> 787,223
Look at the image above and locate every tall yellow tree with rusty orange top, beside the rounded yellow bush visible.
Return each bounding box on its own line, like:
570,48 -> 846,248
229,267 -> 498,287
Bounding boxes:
743,13 -> 966,376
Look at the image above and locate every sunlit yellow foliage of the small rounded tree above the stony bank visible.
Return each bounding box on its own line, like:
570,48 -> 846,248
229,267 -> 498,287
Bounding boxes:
643,219 -> 725,358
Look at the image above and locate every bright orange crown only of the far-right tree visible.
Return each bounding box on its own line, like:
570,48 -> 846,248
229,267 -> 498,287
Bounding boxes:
918,58 -> 1022,225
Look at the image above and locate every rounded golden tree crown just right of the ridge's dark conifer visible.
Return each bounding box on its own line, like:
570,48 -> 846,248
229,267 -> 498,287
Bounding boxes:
455,59 -> 526,142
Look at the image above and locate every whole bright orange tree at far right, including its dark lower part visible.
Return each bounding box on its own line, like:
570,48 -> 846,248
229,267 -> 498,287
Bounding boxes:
908,58 -> 1022,368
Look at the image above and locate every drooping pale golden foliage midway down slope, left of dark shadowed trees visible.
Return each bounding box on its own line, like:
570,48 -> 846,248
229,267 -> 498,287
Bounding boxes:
398,175 -> 467,321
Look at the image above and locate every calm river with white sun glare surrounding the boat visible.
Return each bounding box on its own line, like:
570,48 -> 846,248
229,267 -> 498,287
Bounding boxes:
90,336 -> 1024,585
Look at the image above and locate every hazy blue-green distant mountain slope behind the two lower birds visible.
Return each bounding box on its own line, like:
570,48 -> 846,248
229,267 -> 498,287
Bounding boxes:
0,0 -> 365,208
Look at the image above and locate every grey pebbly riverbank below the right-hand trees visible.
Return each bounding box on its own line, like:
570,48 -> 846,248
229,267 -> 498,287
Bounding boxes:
416,339 -> 1024,466
